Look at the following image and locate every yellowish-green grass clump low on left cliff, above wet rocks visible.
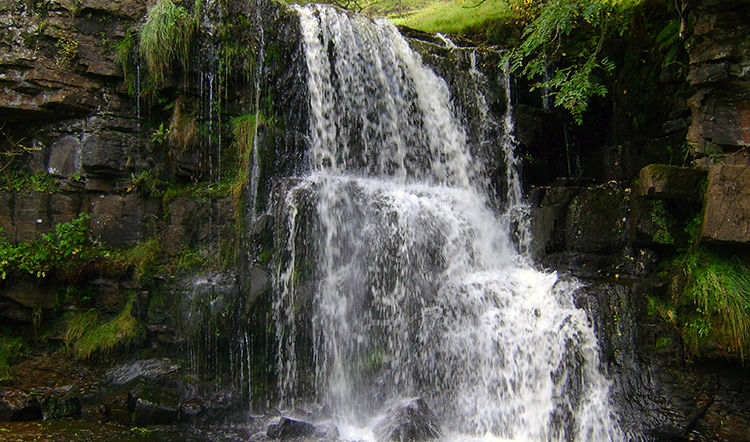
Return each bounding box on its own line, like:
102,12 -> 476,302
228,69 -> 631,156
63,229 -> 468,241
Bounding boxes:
64,297 -> 142,359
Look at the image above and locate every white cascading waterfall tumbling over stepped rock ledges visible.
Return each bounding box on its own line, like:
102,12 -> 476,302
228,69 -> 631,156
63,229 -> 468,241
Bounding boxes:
274,6 -> 621,440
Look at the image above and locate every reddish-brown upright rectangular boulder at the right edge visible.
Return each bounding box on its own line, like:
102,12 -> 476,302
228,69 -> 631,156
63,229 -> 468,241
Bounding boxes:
701,166 -> 750,245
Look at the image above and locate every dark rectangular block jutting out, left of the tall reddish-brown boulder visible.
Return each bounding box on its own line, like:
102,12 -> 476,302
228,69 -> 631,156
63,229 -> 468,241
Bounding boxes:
634,164 -> 706,200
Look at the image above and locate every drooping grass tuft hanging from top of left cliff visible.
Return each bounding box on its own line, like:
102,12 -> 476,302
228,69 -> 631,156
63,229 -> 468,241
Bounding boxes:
138,0 -> 196,85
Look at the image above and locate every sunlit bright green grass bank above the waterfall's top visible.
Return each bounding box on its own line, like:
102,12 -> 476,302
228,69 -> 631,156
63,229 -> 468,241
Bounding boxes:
391,0 -> 510,34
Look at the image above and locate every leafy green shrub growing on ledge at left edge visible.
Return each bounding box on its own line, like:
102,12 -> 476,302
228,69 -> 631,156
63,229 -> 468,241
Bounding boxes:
0,214 -> 109,280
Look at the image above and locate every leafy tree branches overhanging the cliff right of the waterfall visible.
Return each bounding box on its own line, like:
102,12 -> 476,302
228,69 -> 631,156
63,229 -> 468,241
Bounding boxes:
506,0 -> 639,124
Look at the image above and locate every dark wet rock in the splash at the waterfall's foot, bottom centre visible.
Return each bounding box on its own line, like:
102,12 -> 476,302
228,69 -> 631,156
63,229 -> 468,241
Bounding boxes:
375,398 -> 441,442
